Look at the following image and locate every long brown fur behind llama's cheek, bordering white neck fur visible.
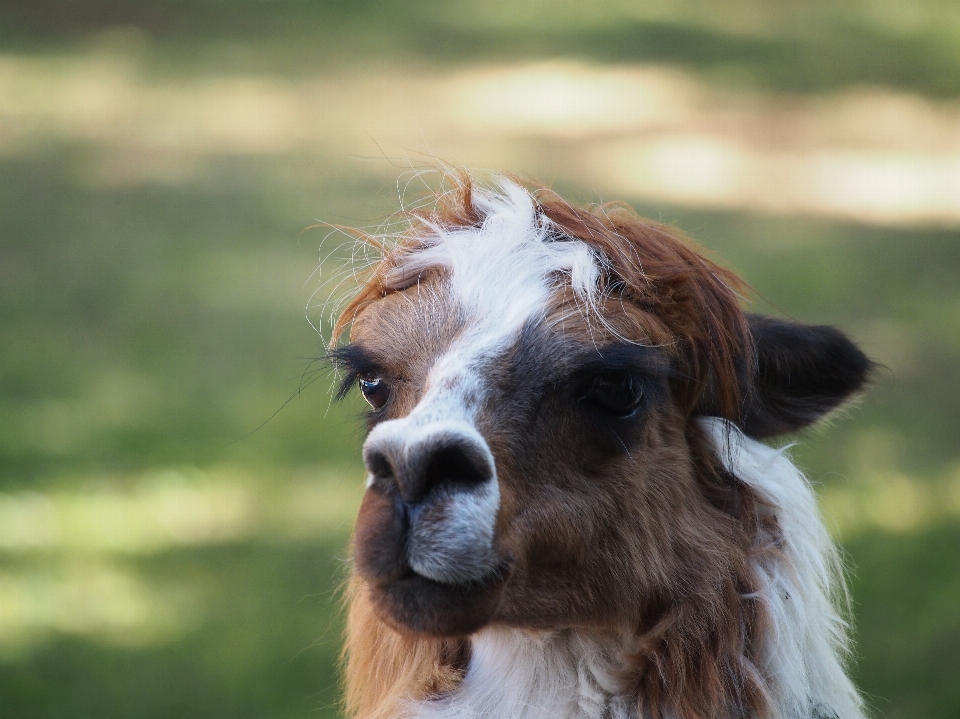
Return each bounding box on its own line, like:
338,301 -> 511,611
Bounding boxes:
631,422 -> 778,719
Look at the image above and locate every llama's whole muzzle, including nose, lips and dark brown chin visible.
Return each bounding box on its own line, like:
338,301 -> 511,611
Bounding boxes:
355,419 -> 508,635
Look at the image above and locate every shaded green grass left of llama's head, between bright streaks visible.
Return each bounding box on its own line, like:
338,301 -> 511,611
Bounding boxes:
0,155 -> 372,482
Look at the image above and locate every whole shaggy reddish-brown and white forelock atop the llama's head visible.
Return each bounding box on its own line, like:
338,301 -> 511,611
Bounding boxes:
332,171 -> 753,420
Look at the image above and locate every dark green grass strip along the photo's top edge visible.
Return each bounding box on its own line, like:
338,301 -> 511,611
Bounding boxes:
0,0 -> 960,97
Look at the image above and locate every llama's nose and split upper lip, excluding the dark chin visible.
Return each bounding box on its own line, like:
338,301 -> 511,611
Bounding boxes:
357,419 -> 500,585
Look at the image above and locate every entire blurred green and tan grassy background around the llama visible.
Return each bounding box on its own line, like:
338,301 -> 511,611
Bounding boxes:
0,0 -> 960,719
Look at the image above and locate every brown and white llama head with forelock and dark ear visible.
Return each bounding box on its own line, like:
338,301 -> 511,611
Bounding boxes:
335,178 -> 870,719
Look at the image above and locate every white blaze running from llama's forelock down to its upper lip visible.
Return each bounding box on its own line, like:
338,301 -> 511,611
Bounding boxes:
364,181 -> 600,583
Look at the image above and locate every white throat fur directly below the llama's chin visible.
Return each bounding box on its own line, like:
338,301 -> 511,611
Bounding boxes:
411,627 -> 636,719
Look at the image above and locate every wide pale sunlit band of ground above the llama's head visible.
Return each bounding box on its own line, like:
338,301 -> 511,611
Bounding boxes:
0,46 -> 960,225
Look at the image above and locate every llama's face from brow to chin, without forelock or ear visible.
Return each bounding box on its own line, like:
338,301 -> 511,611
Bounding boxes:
350,275 -> 691,634
